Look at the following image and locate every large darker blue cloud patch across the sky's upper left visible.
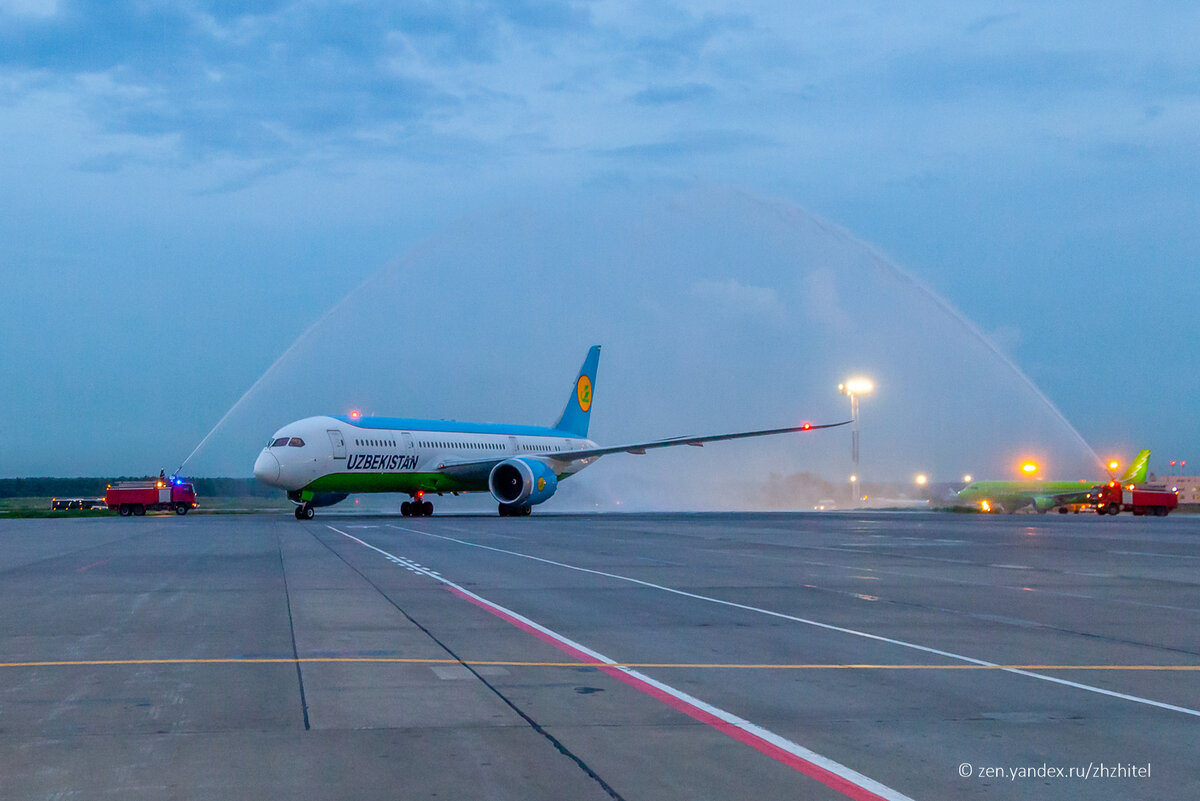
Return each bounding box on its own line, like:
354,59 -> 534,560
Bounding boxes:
0,0 -> 589,169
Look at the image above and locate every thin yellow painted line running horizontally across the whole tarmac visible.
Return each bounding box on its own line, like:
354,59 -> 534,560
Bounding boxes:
0,656 -> 1200,671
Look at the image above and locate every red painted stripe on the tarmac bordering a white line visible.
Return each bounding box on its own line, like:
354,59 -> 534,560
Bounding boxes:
446,586 -> 902,801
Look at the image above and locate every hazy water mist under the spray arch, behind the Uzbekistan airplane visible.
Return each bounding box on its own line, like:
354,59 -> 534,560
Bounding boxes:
175,186 -> 1098,510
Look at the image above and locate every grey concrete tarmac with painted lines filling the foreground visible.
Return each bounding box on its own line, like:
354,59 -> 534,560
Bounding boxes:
0,510 -> 1200,801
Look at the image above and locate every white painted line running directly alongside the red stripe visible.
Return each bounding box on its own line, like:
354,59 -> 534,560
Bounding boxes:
326,525 -> 913,801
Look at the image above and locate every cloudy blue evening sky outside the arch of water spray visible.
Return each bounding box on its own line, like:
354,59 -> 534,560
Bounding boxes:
0,0 -> 1200,475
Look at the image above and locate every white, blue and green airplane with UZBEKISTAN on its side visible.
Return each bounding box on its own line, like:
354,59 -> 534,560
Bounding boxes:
254,345 -> 850,520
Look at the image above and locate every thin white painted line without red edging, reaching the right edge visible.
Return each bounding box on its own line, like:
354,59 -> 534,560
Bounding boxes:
391,525 -> 1200,717
